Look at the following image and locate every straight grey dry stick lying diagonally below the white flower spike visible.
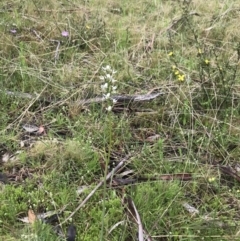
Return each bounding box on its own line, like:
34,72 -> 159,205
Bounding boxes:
59,154 -> 132,225
